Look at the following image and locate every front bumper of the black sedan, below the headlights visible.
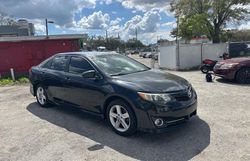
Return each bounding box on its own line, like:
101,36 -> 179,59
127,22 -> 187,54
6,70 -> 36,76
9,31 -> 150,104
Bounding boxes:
136,96 -> 197,133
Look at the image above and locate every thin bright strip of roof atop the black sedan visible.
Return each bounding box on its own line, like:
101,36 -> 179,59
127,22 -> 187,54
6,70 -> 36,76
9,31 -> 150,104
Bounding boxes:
56,51 -> 118,57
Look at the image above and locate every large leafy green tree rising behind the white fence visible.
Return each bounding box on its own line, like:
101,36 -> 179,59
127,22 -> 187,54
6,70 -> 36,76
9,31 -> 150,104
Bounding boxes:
171,0 -> 250,43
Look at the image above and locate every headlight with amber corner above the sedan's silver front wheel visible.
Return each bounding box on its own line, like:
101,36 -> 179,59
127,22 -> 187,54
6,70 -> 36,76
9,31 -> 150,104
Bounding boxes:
138,92 -> 172,104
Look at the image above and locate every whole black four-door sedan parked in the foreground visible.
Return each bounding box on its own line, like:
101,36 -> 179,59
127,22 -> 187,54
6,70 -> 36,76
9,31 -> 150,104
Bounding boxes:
30,52 -> 197,136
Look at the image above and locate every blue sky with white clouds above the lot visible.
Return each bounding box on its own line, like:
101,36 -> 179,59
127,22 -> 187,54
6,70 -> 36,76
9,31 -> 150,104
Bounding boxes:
0,0 -> 250,44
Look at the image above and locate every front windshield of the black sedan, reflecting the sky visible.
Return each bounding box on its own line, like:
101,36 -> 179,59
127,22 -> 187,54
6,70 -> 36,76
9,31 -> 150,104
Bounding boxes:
93,54 -> 150,76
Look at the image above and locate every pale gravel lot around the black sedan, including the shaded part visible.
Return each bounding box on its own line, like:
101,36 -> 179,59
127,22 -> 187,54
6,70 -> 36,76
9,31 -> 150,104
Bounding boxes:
0,54 -> 250,161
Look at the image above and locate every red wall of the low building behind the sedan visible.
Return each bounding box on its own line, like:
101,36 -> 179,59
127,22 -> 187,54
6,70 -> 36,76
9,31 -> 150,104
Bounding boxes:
0,39 -> 79,74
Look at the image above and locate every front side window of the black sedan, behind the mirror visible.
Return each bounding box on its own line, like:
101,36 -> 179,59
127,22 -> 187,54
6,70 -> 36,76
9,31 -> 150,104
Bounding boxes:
69,56 -> 94,74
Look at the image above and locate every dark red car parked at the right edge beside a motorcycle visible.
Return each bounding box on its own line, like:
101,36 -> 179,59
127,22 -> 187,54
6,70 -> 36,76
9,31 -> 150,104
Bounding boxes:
214,57 -> 250,84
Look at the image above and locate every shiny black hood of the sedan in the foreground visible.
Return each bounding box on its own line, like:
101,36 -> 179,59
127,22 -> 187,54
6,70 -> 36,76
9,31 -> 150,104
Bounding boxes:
115,69 -> 190,93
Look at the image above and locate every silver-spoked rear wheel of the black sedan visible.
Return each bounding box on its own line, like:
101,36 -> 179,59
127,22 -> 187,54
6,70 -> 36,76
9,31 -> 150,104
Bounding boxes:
36,85 -> 50,107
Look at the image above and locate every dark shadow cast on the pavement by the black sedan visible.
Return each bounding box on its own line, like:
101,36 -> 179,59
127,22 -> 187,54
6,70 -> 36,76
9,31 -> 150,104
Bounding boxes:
27,103 -> 210,161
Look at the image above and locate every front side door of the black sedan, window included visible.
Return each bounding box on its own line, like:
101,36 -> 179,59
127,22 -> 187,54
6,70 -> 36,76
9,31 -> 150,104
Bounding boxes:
65,56 -> 105,113
